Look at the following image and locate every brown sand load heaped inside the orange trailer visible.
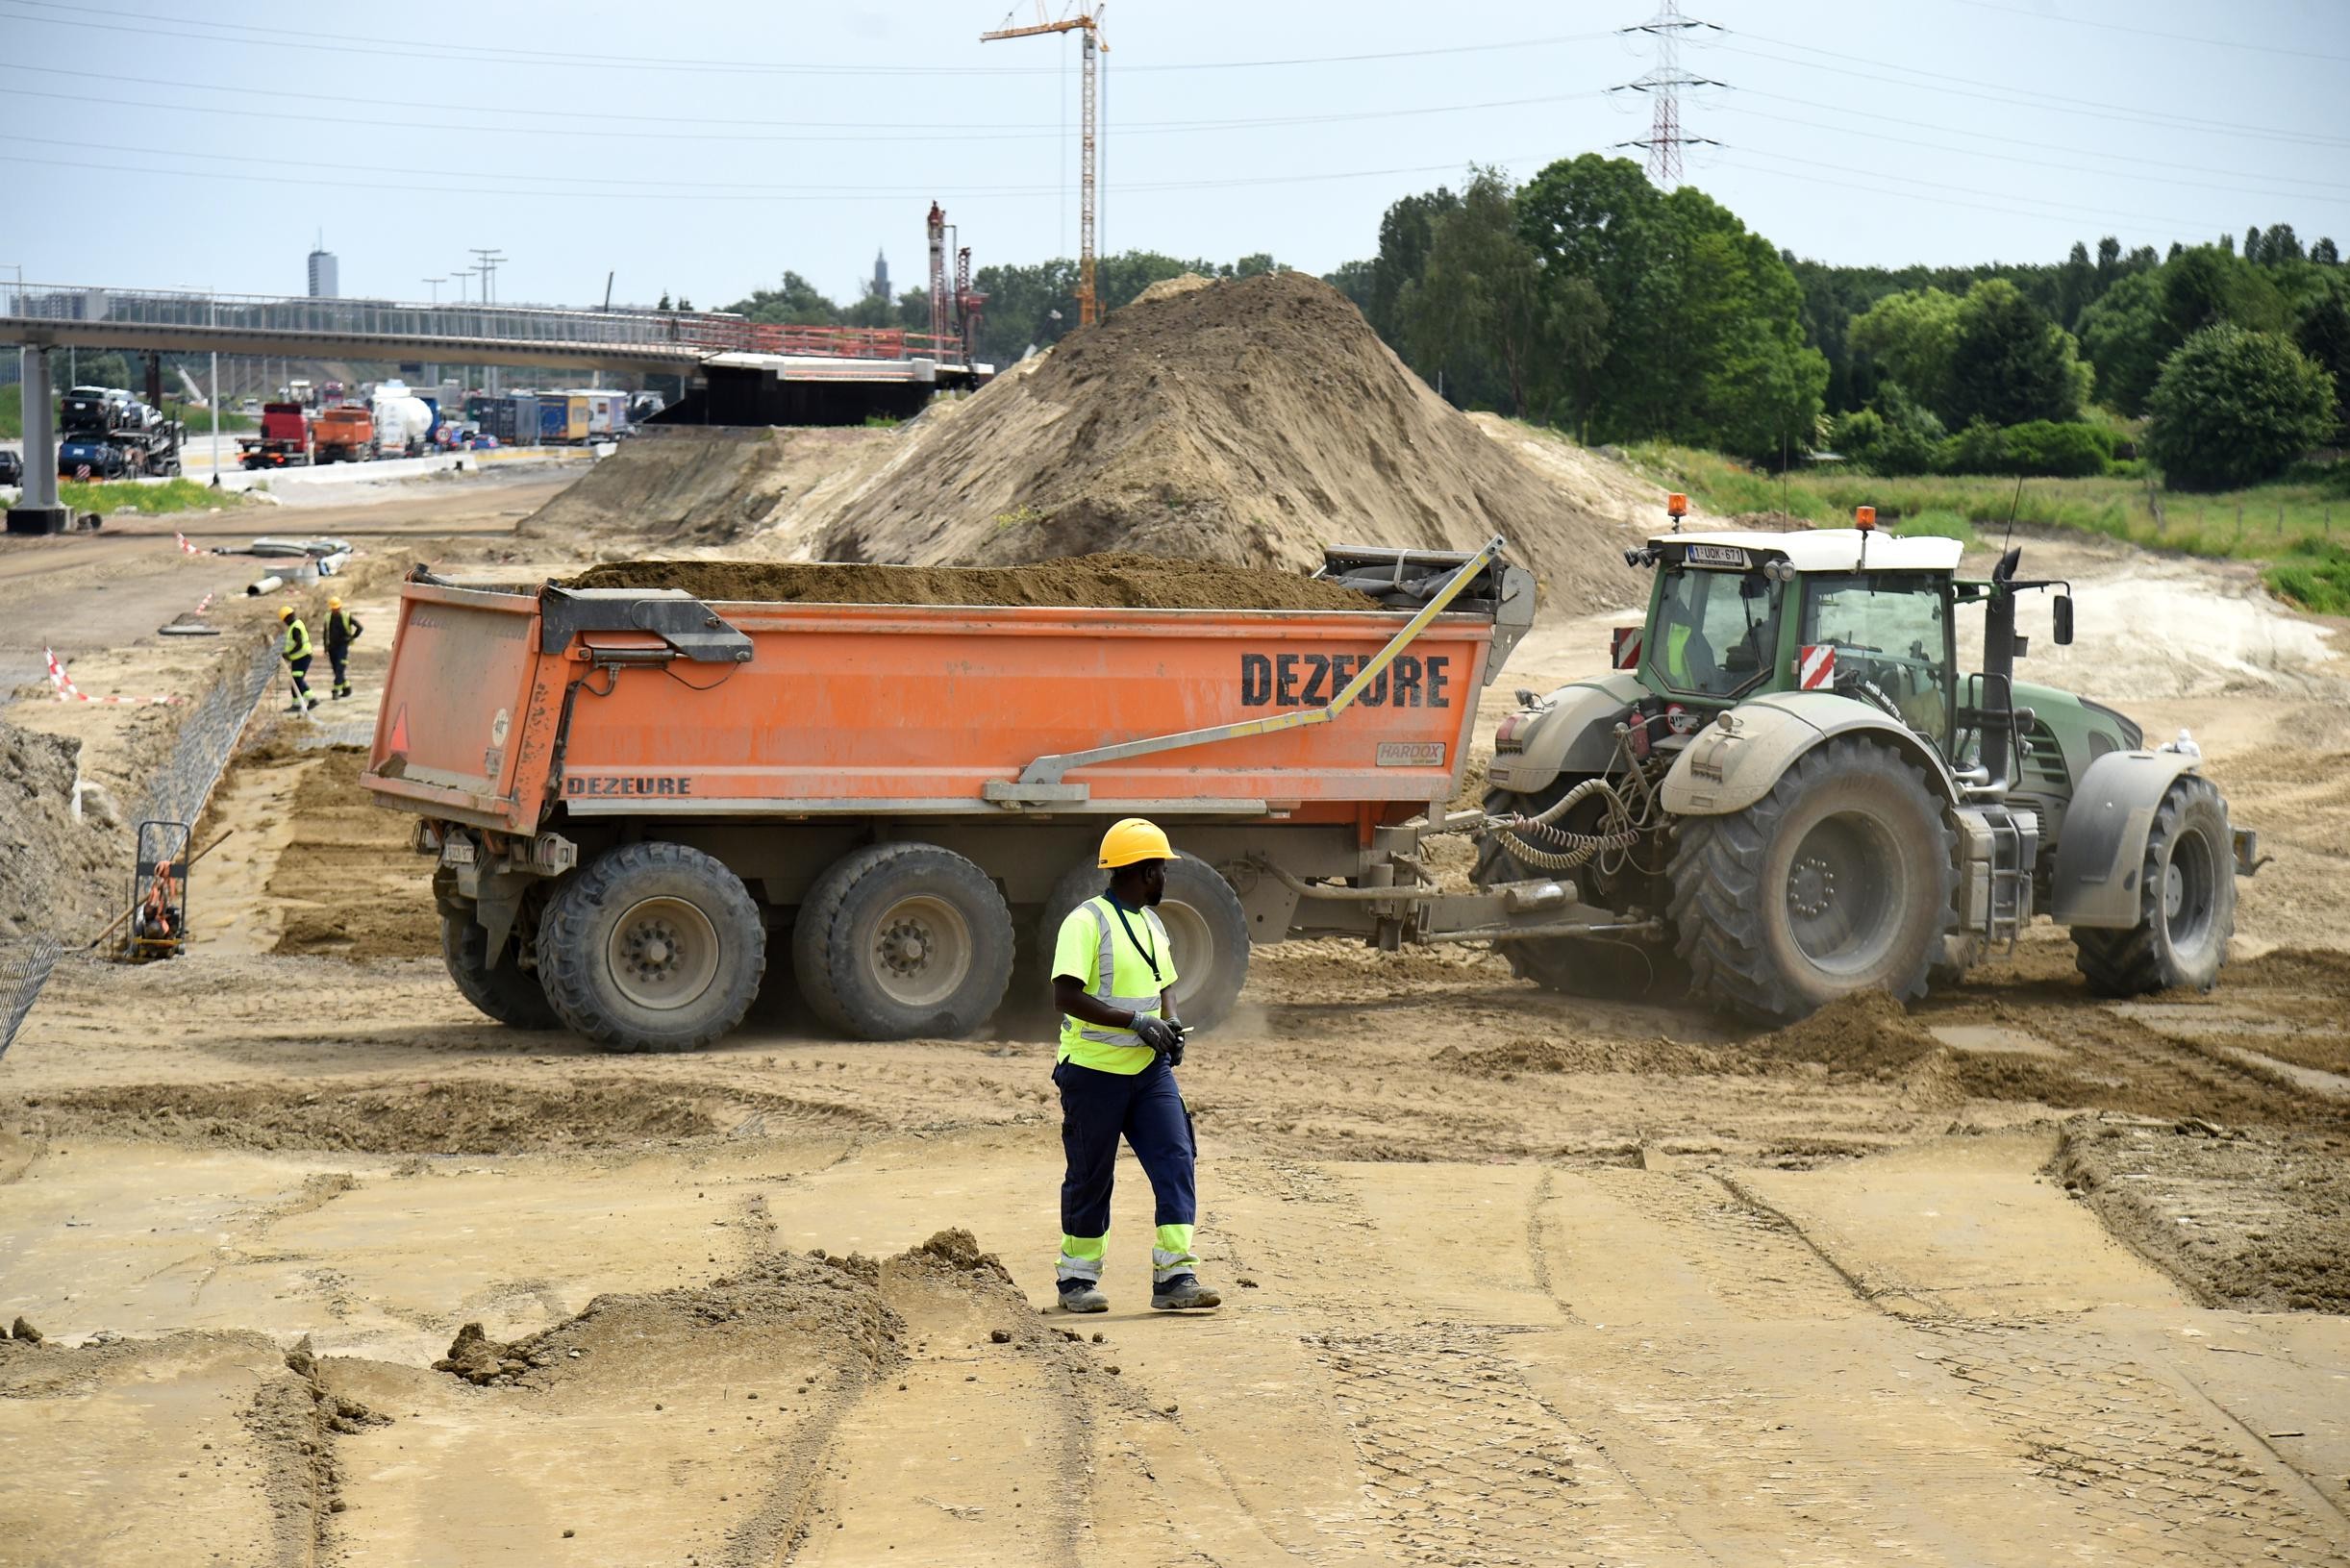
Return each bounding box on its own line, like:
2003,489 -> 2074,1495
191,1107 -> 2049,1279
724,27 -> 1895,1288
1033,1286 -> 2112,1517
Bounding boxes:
568,555 -> 1377,609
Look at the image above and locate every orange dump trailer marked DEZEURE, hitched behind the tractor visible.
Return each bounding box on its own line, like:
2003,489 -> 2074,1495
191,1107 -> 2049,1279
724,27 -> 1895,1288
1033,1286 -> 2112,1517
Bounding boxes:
364,540 -> 1614,1051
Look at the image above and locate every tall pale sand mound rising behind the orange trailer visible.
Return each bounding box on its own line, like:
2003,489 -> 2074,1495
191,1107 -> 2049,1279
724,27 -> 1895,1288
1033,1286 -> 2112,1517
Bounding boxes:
804,273 -> 1645,609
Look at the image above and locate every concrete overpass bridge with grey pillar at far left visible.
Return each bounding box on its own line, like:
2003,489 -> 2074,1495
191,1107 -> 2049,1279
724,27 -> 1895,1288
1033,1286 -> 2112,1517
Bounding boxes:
0,282 -> 989,532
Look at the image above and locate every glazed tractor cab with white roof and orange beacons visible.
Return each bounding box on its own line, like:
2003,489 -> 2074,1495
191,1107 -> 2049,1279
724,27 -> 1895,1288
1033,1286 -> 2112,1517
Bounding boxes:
1614,514 -> 1960,757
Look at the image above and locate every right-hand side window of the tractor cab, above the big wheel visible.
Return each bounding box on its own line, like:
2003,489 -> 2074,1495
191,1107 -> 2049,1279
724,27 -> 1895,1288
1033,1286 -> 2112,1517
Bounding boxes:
1800,571 -> 1953,748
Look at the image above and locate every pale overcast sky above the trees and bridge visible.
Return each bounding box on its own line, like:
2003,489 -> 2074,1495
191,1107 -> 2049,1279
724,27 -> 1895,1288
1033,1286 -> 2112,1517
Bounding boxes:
0,0 -> 2350,308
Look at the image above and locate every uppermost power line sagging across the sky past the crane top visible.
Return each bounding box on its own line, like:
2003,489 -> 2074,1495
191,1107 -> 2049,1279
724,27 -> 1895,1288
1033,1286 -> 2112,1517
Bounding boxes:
0,0 -> 1608,78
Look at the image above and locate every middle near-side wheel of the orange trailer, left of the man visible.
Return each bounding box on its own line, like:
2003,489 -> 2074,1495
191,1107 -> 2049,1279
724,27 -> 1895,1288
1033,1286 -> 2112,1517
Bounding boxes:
792,844 -> 1012,1039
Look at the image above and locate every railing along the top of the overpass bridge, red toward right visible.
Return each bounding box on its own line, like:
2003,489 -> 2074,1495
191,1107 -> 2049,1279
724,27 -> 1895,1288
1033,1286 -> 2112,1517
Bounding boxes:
0,282 -> 962,360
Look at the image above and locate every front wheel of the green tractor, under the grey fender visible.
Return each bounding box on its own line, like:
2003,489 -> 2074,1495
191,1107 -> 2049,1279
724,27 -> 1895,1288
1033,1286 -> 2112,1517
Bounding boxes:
2073,773 -> 2235,997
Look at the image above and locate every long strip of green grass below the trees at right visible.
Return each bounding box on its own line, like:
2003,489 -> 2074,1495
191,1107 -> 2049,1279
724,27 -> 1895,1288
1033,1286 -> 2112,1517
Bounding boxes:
1626,444 -> 2350,560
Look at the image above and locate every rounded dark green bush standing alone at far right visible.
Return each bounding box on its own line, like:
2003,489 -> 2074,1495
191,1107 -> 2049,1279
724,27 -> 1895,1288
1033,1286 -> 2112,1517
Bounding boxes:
2143,327 -> 2334,489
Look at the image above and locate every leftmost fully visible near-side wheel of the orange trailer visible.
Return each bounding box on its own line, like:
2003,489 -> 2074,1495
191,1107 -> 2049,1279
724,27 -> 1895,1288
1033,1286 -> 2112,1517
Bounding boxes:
538,841 -> 766,1051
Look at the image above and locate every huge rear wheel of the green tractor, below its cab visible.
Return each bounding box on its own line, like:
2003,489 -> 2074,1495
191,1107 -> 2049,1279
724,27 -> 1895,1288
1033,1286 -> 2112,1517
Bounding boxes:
1671,738 -> 1958,1023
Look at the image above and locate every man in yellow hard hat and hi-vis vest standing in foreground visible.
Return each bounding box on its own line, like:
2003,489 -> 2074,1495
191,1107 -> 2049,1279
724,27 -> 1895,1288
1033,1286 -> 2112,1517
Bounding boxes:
1053,816 -> 1222,1311
